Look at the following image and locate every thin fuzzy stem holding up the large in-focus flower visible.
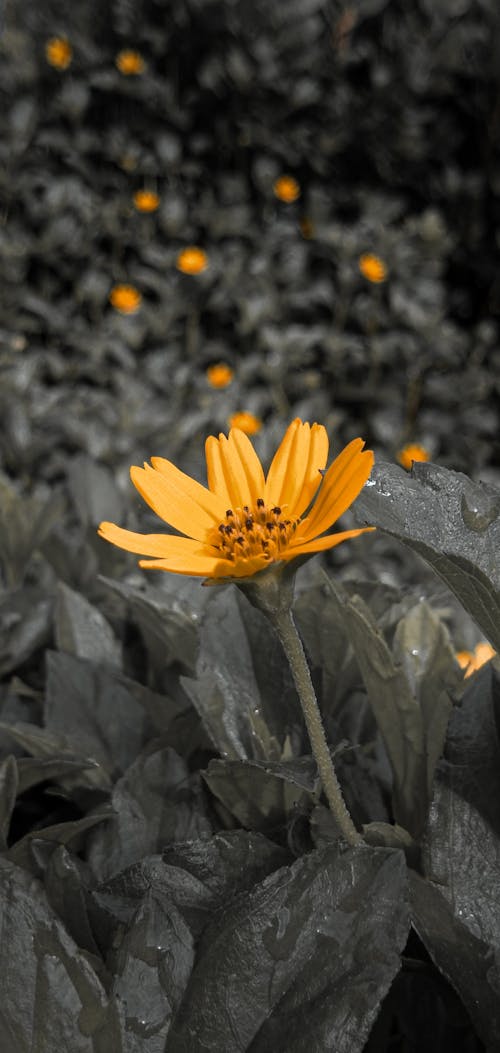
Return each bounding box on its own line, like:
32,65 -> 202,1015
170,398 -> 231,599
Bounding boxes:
267,609 -> 363,845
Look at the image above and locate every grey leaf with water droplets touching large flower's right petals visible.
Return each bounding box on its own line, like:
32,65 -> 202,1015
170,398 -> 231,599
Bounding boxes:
356,463 -> 500,651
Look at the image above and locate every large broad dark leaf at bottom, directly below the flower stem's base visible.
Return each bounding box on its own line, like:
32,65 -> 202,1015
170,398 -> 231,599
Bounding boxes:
166,848 -> 408,1053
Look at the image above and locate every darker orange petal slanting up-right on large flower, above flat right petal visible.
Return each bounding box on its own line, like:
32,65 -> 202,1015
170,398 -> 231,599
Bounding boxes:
296,439 -> 374,542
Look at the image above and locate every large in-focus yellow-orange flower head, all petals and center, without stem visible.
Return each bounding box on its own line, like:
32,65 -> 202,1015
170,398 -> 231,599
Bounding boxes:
99,419 -> 374,580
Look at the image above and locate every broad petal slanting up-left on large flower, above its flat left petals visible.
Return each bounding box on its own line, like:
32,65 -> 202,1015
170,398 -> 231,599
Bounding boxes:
131,462 -> 220,541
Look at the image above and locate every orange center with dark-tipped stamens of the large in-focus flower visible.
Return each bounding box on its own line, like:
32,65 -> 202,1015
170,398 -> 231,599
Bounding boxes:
209,497 -> 299,563
